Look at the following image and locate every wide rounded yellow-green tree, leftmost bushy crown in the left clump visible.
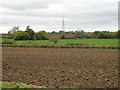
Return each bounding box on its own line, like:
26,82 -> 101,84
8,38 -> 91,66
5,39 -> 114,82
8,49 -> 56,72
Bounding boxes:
14,31 -> 30,40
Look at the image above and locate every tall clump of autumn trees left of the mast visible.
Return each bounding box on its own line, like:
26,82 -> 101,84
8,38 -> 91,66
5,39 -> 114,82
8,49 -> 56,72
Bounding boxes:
8,26 -> 47,40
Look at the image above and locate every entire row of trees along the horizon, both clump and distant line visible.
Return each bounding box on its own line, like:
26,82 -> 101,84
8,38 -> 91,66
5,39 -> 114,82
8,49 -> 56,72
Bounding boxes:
8,26 -> 120,40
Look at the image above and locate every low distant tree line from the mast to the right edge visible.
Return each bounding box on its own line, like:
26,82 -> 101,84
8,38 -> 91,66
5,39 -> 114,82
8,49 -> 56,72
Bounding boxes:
50,30 -> 120,39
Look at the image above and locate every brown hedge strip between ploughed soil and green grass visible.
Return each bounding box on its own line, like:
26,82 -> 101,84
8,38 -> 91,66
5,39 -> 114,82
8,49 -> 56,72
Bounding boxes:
0,44 -> 120,49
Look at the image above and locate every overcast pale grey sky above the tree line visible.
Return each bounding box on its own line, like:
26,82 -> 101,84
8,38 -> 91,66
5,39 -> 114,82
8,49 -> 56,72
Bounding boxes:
0,0 -> 119,33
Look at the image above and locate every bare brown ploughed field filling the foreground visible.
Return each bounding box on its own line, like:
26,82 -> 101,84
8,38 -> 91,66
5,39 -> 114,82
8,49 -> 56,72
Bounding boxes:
2,48 -> 118,88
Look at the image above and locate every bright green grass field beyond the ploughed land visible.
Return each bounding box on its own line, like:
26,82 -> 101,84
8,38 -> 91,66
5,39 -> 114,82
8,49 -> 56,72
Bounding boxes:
0,38 -> 118,46
